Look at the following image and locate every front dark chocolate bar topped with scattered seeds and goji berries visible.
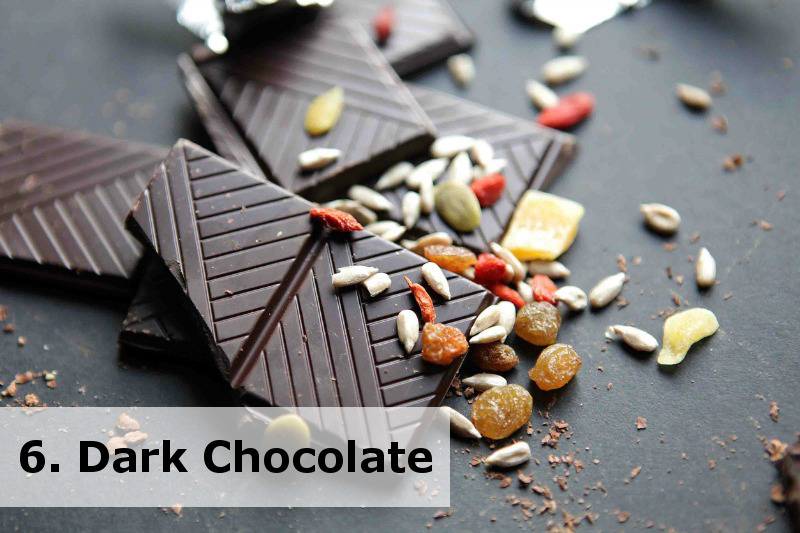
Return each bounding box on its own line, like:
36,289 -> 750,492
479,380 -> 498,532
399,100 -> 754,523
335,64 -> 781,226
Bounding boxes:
128,141 -> 492,407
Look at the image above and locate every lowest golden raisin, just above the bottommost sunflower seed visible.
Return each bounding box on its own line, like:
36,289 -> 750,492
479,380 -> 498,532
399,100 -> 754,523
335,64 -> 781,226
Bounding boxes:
472,385 -> 533,439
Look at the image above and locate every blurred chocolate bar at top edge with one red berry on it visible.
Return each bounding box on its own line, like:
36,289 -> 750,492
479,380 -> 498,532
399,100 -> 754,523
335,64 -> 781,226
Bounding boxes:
327,0 -> 474,76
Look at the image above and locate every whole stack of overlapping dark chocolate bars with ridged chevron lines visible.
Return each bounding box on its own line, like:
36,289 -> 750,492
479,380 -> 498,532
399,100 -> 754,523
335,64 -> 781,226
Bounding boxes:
0,0 -> 574,414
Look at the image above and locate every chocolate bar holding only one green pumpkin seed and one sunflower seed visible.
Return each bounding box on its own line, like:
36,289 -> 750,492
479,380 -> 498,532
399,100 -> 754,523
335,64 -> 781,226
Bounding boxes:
180,20 -> 433,198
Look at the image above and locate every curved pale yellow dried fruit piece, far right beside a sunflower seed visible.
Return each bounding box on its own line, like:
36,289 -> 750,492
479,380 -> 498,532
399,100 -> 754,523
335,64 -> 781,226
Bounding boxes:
658,307 -> 719,365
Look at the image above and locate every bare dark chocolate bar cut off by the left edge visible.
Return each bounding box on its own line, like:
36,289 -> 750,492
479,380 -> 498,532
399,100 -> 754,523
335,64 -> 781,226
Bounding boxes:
0,120 -> 167,291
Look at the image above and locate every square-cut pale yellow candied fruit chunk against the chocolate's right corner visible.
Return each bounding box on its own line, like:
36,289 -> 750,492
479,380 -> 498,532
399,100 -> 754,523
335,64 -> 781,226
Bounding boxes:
501,190 -> 584,261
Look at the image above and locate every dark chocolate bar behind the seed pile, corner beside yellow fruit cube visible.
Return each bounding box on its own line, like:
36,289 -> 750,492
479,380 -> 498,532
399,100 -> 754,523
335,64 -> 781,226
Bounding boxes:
368,84 -> 575,251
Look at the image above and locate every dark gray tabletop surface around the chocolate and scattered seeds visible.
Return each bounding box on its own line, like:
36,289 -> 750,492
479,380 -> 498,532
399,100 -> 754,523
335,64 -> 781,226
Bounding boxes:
0,0 -> 800,531
